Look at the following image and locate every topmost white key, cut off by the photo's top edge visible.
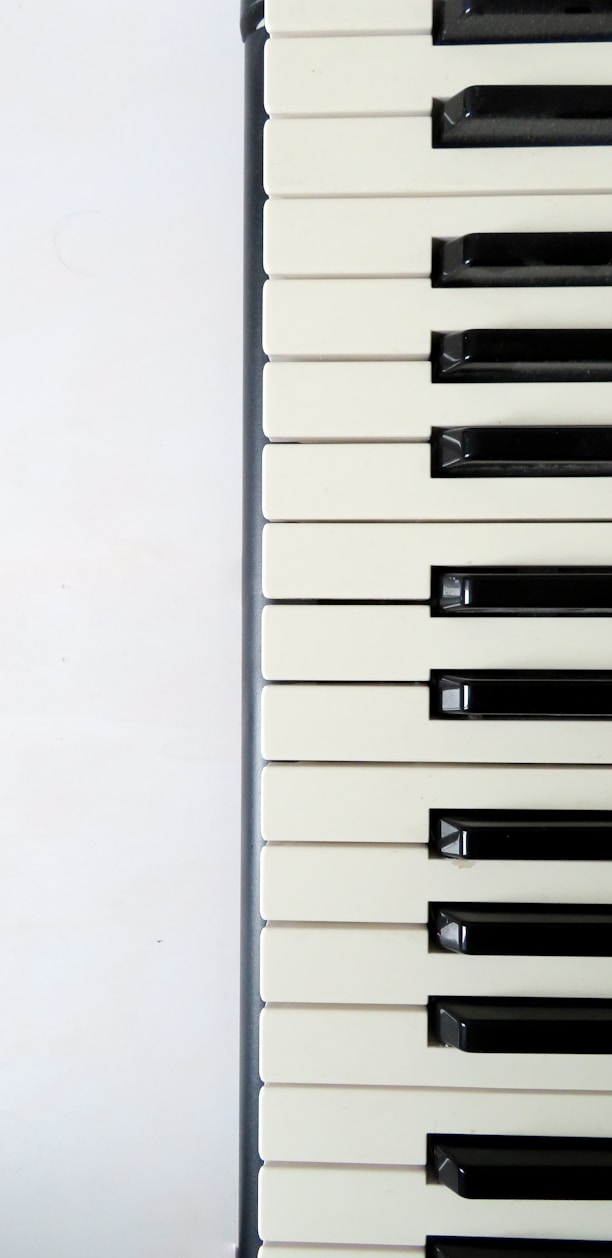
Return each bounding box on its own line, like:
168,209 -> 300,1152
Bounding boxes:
266,0 -> 432,35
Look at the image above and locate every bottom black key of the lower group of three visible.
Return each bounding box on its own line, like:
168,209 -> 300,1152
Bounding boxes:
429,996 -> 612,1054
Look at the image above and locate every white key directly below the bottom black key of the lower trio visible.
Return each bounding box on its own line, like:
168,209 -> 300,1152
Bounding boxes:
259,1005 -> 612,1092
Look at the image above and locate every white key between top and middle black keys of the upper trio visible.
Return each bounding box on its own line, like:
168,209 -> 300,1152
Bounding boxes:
263,279 -> 612,354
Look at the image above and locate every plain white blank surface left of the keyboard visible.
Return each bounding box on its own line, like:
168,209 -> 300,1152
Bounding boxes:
0,0 -> 242,1258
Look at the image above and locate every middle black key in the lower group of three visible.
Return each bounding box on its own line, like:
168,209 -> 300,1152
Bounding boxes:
429,903 -> 612,956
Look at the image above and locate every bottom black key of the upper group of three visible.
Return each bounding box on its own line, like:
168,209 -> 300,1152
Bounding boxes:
431,425 -> 612,478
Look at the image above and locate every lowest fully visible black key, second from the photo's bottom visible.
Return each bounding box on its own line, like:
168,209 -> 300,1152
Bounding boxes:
427,1135 -> 612,1201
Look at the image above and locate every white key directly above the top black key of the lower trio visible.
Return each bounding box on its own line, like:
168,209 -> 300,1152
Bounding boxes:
262,765 -> 612,844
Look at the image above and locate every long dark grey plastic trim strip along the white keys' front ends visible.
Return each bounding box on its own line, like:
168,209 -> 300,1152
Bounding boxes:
238,24 -> 267,1258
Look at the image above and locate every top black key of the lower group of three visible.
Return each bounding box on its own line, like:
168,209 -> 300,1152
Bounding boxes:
429,809 -> 612,860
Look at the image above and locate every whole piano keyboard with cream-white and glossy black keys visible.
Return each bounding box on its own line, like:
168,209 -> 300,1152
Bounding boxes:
239,7 -> 612,1258
